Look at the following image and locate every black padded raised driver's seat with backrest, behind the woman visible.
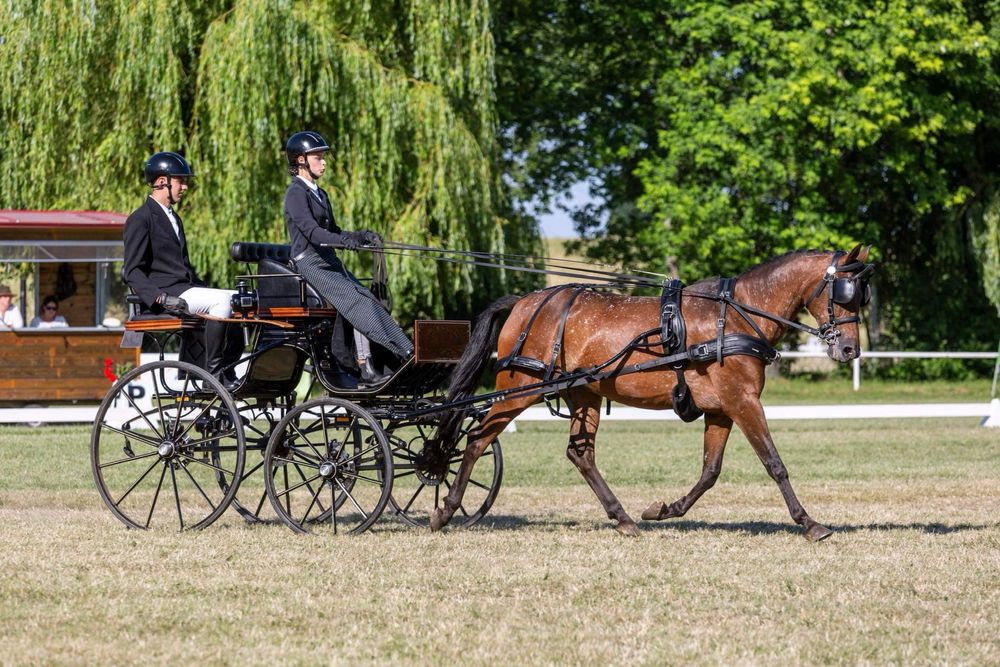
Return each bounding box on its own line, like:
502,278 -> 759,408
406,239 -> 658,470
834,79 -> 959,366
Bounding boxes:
229,241 -> 323,308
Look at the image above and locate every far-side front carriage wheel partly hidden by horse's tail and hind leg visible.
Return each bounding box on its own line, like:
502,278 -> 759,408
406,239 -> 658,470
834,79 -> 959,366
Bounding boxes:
387,415 -> 503,527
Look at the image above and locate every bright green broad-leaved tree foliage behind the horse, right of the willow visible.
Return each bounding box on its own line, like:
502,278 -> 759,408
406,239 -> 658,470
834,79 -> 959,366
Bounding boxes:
498,0 -> 1000,348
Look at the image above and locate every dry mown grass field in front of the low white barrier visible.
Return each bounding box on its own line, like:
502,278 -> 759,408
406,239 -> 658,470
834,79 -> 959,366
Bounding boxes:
0,420 -> 1000,665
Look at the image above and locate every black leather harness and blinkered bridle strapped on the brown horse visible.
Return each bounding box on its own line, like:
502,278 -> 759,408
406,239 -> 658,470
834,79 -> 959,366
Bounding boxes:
496,252 -> 874,422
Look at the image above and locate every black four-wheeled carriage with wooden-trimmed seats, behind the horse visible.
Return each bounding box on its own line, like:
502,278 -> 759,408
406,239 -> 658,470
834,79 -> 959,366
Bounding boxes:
91,243 -> 503,533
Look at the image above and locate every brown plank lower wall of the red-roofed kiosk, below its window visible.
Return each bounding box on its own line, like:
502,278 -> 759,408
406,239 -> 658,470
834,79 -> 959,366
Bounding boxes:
0,330 -> 139,403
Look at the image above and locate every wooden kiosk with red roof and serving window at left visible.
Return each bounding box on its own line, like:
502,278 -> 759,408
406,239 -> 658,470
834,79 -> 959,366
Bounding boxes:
0,210 -> 139,406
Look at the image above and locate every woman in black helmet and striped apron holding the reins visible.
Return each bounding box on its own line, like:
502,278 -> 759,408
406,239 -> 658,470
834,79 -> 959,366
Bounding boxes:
285,131 -> 413,386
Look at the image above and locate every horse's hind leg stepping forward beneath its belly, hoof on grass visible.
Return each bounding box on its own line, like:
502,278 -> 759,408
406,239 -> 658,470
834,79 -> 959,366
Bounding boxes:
566,390 -> 639,536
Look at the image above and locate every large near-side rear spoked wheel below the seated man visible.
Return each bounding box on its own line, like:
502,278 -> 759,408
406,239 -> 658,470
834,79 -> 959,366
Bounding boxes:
90,361 -> 246,530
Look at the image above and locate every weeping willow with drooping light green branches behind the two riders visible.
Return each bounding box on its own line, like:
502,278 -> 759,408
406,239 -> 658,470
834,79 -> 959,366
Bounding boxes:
0,0 -> 538,318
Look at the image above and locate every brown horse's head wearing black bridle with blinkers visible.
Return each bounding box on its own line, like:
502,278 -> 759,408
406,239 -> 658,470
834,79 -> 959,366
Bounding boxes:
806,245 -> 875,361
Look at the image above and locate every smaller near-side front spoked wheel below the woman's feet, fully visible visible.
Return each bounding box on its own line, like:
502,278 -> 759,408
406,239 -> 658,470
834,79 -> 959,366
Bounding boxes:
264,398 -> 392,533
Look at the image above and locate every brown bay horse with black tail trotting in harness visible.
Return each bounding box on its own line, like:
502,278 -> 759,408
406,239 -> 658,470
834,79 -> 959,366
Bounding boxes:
430,246 -> 873,541
